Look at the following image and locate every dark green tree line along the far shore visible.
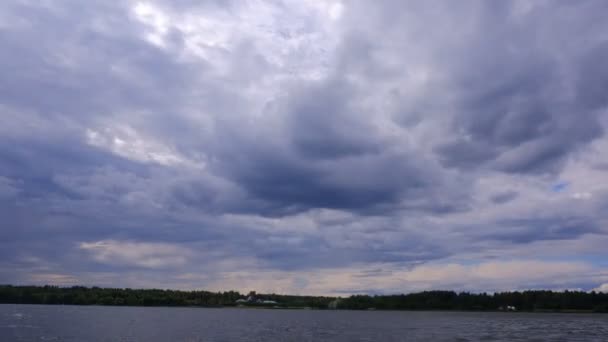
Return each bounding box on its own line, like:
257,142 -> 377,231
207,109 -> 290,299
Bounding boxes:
0,285 -> 608,312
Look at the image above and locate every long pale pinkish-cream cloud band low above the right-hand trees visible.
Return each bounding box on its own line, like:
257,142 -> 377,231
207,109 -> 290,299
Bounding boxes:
194,260 -> 602,295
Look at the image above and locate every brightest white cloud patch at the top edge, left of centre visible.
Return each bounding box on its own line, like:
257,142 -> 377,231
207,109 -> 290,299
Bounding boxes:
132,1 -> 343,79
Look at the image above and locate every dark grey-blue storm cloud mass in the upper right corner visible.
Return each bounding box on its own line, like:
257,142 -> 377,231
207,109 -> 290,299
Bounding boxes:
437,3 -> 605,173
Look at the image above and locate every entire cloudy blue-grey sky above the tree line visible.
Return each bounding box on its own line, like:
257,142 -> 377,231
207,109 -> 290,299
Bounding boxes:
0,0 -> 608,296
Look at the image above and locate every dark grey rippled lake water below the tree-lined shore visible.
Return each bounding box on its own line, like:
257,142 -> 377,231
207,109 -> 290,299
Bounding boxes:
0,305 -> 608,342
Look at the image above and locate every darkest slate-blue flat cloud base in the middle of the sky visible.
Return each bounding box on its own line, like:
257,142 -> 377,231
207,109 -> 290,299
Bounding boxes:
214,146 -> 431,211
